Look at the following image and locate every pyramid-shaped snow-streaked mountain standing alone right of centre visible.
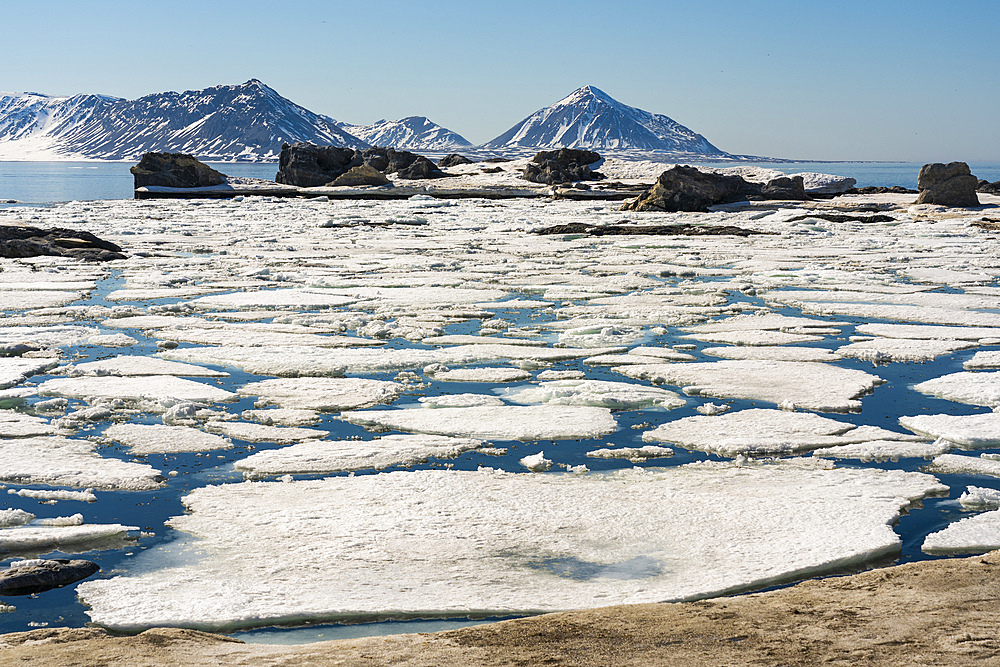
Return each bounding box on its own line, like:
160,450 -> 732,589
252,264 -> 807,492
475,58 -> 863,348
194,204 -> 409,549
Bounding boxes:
483,86 -> 726,155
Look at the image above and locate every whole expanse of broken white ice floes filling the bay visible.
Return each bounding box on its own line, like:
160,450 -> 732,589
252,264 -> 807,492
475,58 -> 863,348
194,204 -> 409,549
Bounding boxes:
0,185 -> 1000,630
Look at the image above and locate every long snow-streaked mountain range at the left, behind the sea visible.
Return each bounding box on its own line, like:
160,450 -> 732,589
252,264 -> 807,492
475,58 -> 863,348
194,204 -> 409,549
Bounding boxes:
0,79 -> 368,162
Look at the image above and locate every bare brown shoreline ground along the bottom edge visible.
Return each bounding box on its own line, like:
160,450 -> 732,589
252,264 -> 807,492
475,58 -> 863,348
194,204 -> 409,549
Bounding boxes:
0,551 -> 1000,667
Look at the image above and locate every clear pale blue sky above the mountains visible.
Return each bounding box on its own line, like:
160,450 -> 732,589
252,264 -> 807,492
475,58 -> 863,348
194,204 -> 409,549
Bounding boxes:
0,0 -> 1000,161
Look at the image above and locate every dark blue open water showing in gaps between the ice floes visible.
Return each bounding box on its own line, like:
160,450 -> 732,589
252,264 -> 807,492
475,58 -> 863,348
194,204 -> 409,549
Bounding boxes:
0,264 -> 1000,643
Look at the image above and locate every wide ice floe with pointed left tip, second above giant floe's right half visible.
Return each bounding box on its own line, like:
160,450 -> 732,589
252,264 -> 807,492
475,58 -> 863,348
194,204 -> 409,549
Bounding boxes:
614,360 -> 881,412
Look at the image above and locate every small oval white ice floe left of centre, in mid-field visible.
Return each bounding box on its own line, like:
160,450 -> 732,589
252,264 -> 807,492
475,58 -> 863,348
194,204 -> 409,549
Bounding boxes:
238,377 -> 404,412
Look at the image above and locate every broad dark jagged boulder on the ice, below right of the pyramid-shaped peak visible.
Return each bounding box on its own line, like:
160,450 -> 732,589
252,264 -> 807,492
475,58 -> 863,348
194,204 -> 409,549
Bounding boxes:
621,165 -> 761,212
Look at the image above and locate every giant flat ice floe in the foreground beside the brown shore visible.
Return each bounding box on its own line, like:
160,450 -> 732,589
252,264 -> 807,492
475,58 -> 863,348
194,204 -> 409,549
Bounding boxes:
77,464 -> 945,630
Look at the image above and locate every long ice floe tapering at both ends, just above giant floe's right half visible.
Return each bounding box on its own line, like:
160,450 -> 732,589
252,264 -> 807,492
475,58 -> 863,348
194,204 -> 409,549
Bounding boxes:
642,408 -> 919,457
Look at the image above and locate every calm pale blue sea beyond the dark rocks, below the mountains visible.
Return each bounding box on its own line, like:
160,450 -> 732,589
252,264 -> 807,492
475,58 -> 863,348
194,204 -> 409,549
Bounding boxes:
0,162 -> 1000,205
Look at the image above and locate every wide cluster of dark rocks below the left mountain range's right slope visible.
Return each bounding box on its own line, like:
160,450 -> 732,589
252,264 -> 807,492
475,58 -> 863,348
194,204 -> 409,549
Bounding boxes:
274,142 -> 448,188
